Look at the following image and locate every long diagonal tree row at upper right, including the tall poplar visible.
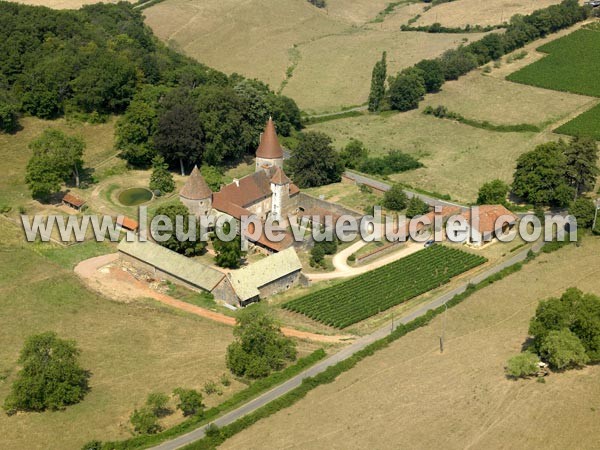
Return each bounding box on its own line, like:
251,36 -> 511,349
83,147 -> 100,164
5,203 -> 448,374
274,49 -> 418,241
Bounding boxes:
369,0 -> 590,111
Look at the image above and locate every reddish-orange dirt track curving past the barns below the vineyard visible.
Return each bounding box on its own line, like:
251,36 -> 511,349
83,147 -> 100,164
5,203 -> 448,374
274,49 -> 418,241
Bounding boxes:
75,253 -> 355,343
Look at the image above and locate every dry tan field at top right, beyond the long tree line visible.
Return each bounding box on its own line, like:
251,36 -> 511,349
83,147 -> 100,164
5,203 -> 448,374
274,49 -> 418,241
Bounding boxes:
414,0 -> 560,27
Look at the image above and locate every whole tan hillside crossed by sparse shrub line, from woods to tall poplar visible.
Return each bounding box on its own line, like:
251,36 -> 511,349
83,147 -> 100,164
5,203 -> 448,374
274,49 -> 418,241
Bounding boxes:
144,0 -> 481,113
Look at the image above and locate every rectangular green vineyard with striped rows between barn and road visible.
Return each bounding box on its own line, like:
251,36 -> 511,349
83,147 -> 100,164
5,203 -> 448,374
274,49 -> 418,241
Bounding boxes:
283,245 -> 486,328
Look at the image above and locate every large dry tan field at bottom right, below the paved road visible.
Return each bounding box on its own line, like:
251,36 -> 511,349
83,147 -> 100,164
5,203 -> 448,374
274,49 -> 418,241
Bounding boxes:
219,238 -> 600,450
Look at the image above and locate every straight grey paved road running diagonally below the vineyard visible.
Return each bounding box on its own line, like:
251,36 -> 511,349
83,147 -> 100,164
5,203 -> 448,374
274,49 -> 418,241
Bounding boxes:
153,242 -> 544,450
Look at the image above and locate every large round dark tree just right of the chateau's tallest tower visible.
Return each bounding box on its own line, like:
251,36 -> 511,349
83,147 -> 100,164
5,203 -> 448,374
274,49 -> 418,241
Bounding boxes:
288,131 -> 344,188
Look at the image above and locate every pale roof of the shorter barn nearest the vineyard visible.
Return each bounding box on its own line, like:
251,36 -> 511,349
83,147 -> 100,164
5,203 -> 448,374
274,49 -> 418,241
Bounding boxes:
230,247 -> 302,301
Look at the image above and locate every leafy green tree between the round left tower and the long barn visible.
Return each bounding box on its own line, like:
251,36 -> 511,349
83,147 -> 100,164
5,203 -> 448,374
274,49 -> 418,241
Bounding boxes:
152,201 -> 206,256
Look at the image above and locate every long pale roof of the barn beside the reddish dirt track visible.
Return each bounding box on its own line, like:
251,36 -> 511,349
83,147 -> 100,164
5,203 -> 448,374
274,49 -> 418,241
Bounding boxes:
117,239 -> 225,292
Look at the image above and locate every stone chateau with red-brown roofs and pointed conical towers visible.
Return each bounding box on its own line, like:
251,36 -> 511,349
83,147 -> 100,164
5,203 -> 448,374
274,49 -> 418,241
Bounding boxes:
179,118 -> 300,251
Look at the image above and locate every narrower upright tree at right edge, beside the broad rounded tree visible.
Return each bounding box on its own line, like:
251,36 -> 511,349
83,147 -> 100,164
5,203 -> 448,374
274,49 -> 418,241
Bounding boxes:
565,138 -> 600,198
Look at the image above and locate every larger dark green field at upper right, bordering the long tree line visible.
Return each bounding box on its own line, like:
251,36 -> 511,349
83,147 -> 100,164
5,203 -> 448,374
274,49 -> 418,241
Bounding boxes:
507,29 -> 600,97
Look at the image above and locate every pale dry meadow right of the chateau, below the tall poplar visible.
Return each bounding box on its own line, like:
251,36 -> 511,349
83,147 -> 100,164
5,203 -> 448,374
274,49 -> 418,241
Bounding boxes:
309,110 -> 547,202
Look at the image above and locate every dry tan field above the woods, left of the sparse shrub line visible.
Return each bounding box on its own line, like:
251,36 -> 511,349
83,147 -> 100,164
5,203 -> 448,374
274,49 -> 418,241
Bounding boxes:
144,0 -> 347,89
